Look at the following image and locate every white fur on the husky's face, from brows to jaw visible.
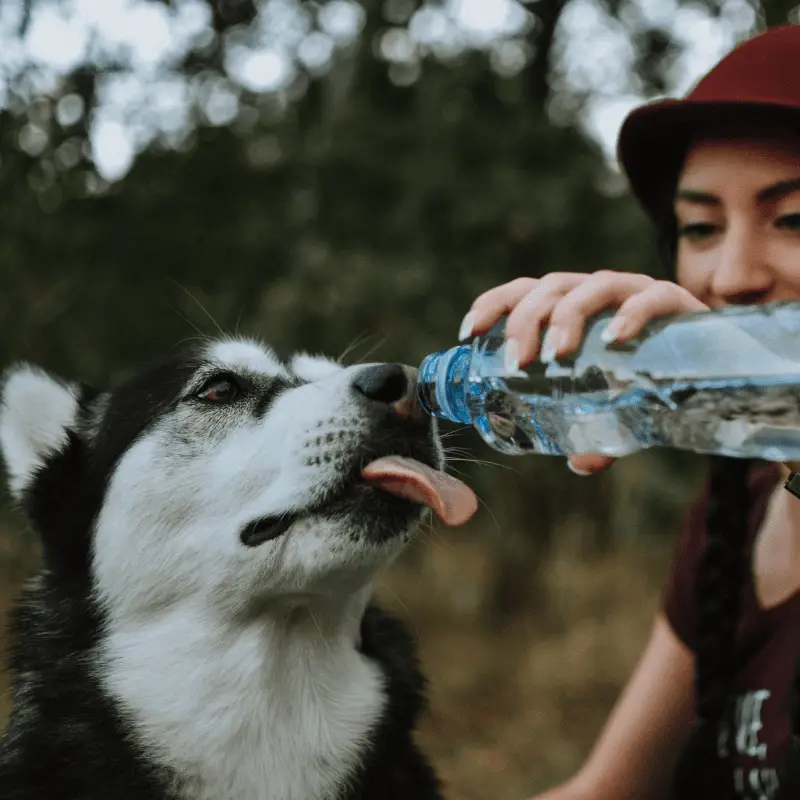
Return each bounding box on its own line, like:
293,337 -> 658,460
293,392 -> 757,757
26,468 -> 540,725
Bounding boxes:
90,342 -> 418,614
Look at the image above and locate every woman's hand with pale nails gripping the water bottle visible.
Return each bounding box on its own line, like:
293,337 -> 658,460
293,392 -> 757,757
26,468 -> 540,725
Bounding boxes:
459,270 -> 708,474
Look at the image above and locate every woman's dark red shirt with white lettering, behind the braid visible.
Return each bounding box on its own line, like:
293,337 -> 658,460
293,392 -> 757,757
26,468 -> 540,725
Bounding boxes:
664,463 -> 800,800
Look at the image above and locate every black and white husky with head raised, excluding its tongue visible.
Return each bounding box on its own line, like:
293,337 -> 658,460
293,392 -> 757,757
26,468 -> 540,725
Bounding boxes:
0,340 -> 443,800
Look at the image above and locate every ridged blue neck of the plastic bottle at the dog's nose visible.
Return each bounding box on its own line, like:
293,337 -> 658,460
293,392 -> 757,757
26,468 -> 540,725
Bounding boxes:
417,344 -> 472,425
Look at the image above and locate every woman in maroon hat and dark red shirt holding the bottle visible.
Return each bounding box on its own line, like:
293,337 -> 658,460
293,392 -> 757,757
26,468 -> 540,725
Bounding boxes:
460,26 -> 800,800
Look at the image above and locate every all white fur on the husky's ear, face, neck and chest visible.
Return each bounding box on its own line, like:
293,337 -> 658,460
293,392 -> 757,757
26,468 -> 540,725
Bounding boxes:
0,341 -> 438,800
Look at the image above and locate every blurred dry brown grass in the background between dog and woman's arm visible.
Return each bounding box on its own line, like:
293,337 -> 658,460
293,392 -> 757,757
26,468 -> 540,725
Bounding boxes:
0,529 -> 667,800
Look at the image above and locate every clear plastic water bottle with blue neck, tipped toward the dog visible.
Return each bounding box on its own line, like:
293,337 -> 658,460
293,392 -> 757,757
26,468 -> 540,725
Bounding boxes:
419,301 -> 800,461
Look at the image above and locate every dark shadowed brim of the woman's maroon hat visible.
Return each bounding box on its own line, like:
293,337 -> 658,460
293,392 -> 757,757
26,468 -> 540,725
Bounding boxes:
617,100 -> 800,219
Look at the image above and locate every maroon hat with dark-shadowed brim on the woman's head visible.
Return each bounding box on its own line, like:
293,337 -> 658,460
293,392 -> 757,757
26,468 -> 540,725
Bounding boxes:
617,25 -> 800,222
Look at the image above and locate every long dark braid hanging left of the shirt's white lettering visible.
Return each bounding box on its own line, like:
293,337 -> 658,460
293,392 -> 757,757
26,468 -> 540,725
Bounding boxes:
673,456 -> 750,798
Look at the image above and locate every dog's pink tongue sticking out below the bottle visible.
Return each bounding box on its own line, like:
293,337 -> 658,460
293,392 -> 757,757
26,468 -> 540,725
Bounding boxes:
361,456 -> 478,525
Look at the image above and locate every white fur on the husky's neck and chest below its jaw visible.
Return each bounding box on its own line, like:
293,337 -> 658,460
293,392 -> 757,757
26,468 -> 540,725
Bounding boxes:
96,590 -> 385,800
